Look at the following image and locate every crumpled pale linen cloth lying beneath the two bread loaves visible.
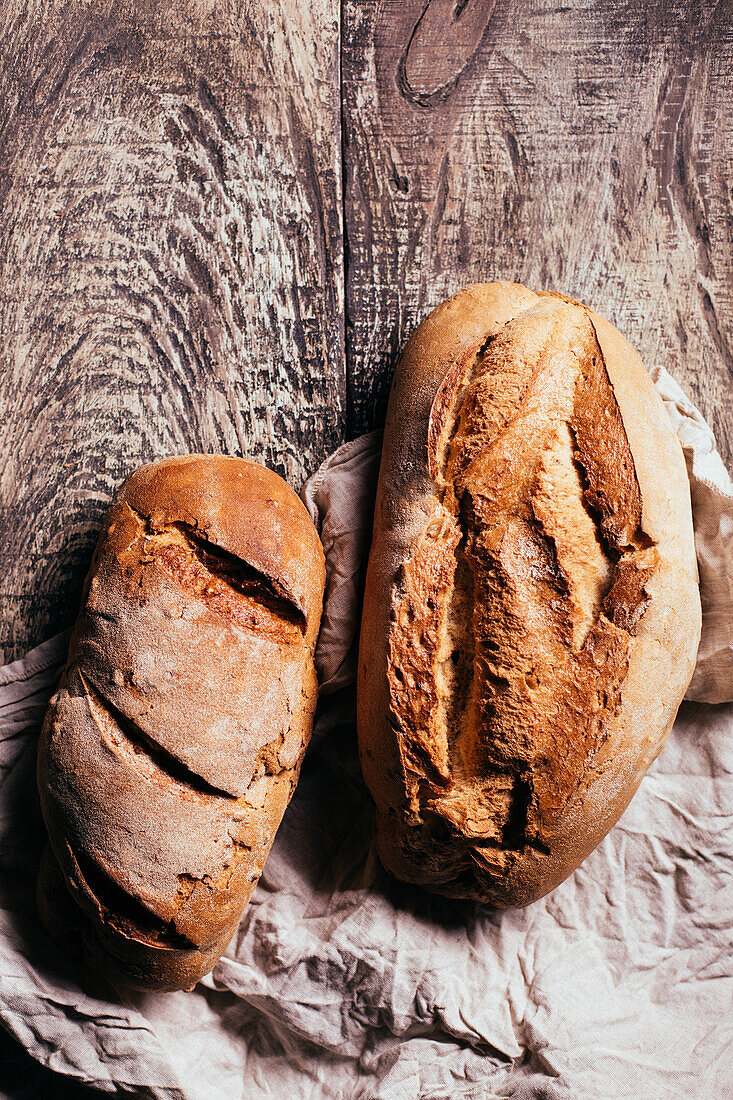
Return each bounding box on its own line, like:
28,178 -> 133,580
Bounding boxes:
0,371 -> 733,1100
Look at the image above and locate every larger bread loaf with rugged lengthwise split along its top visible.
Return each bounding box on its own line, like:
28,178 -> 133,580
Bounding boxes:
358,283 -> 700,906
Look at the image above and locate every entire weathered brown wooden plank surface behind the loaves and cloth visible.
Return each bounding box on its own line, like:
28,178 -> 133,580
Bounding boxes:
0,0 -> 733,659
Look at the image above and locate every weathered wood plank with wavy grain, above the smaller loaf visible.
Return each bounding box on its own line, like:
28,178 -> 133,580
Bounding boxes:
0,0 -> 346,657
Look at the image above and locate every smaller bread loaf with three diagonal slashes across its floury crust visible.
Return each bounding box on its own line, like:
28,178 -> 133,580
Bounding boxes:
39,454 -> 325,990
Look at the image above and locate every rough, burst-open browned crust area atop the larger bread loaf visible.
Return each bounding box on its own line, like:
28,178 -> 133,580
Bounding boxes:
387,300 -> 657,903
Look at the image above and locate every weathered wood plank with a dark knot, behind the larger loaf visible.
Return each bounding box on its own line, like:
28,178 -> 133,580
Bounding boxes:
342,0 -> 733,461
